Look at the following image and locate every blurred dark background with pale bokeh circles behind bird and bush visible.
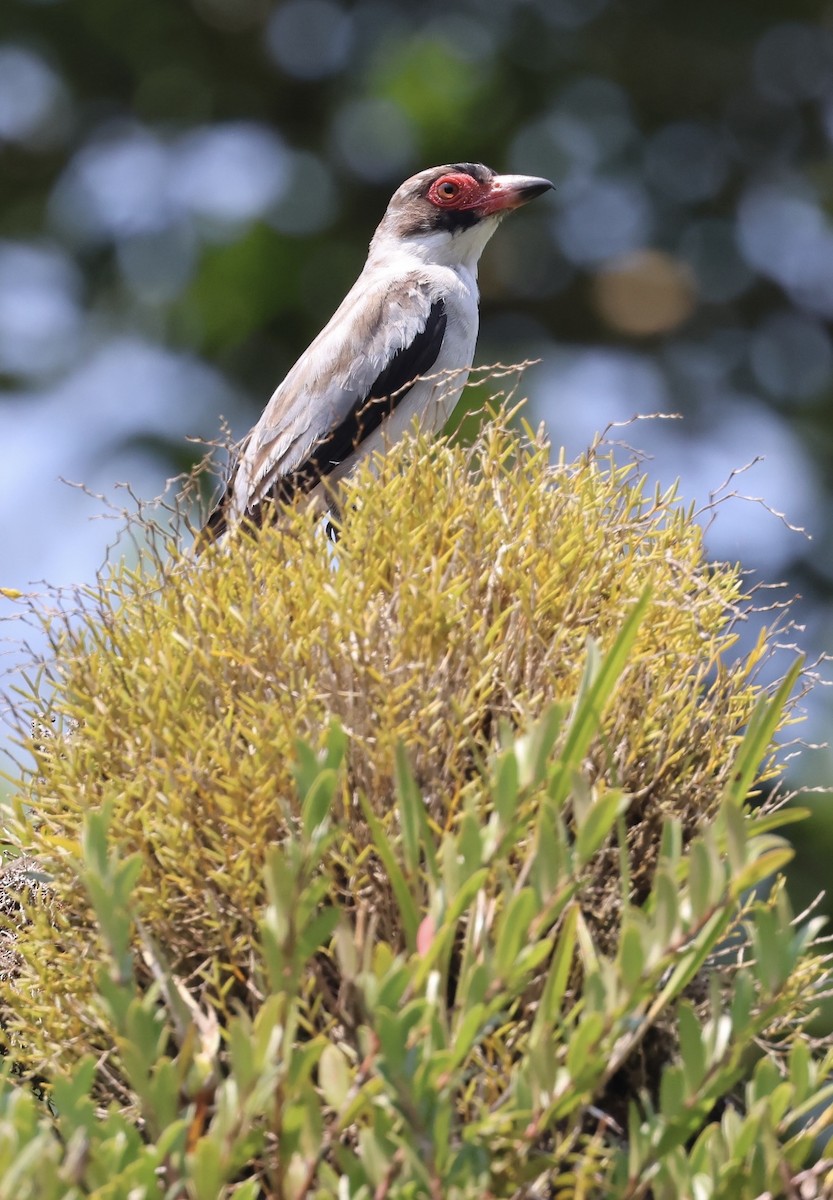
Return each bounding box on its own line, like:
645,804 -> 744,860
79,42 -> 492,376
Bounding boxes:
0,0 -> 833,900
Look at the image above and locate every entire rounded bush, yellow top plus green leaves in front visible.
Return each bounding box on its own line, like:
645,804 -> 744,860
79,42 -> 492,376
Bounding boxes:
0,414 -> 831,1198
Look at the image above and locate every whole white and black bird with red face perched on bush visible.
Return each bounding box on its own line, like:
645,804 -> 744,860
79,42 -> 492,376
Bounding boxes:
204,162 -> 552,540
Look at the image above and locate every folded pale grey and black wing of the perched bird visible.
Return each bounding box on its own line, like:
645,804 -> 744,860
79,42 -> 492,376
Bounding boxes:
226,276 -> 447,520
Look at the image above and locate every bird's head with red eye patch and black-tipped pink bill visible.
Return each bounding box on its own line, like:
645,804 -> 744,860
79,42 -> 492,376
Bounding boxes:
371,162 -> 553,268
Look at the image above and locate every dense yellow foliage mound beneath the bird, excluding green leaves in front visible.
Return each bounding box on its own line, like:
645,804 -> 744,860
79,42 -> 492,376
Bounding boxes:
8,408 -> 787,1094
